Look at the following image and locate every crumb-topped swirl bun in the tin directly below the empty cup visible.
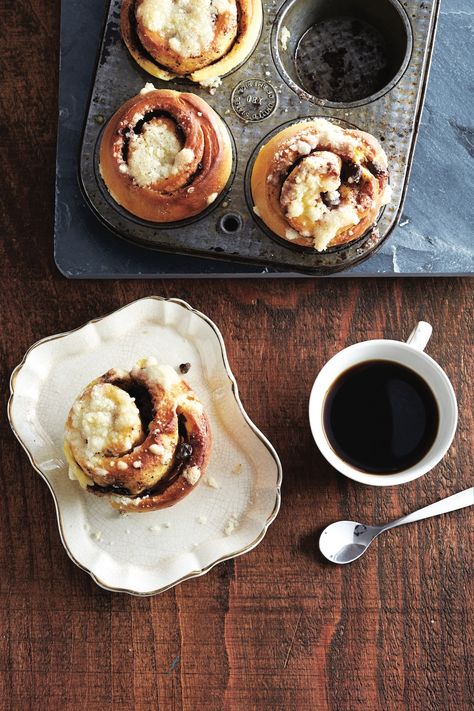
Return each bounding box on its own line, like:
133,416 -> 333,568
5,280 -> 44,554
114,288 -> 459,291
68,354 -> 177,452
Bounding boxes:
251,119 -> 389,252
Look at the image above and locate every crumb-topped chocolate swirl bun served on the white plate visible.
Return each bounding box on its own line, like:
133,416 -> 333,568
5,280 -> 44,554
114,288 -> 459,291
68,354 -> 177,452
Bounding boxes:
64,358 -> 211,511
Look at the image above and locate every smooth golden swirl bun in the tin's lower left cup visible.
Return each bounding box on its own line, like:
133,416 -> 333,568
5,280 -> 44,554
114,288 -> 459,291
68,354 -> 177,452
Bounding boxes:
100,84 -> 232,222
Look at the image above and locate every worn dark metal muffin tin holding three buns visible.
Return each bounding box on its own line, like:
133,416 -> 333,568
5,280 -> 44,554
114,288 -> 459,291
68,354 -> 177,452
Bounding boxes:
80,0 -> 439,274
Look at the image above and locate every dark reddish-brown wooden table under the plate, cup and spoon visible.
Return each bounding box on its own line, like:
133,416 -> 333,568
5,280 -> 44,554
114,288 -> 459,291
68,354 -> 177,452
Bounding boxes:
0,0 -> 474,711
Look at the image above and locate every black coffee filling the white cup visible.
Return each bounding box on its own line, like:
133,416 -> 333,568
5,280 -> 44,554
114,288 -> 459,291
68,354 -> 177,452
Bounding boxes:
323,360 -> 439,474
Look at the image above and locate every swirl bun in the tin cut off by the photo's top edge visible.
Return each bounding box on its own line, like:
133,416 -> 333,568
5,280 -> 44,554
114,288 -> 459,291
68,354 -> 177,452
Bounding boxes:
120,0 -> 262,88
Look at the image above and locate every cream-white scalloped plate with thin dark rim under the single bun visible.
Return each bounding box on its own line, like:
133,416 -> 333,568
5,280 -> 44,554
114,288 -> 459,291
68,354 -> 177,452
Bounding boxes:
8,297 -> 281,595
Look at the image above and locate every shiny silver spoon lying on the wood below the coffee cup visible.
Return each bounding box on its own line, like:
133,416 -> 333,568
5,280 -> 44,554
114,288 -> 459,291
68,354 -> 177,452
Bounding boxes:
319,486 -> 474,563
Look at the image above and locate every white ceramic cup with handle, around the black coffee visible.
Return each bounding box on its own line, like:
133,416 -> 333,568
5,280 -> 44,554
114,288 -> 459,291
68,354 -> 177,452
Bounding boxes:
309,321 -> 458,486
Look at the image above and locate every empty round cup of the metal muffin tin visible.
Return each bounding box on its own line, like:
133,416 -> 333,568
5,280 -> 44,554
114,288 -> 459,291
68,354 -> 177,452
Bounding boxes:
272,0 -> 412,106
